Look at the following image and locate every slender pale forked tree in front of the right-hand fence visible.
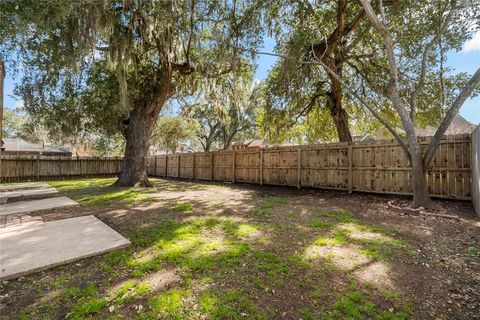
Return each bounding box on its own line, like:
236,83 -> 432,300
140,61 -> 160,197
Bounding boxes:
360,0 -> 480,207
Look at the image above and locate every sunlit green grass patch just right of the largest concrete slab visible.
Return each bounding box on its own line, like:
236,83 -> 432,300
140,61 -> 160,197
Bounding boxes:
127,217 -> 259,276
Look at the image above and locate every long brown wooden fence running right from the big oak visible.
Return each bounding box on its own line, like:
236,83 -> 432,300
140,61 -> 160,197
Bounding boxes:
148,134 -> 472,200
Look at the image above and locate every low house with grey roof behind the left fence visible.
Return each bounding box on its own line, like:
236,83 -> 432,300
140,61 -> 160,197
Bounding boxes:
2,138 -> 72,157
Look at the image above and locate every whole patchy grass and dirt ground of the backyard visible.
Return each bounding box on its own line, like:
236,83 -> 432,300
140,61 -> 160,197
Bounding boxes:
0,179 -> 480,319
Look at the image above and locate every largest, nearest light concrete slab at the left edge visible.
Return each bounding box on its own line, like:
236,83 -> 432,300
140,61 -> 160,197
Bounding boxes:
0,216 -> 130,280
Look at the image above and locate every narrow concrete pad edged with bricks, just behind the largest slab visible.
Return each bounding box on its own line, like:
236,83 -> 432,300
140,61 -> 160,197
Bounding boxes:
0,197 -> 78,216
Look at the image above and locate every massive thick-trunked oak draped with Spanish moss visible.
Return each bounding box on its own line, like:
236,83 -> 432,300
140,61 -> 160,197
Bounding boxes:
0,0 -> 260,186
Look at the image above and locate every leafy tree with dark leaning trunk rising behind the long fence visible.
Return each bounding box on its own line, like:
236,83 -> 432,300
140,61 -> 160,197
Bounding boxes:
266,0 -> 378,142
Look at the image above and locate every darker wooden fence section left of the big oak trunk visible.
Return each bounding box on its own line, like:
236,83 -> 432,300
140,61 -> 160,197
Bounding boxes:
0,156 -> 122,182
